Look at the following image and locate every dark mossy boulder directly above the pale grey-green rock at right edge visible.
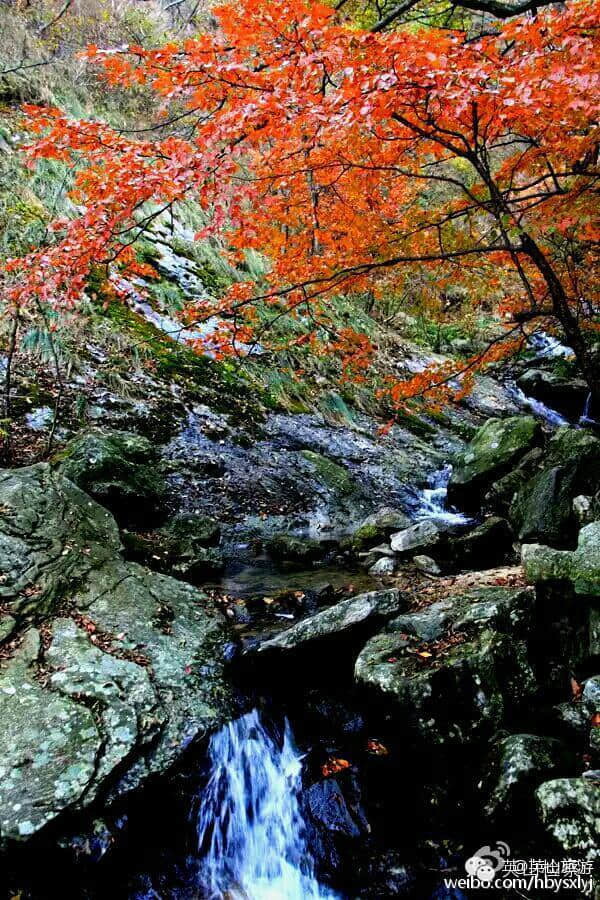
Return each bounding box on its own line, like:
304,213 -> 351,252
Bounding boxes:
510,466 -> 575,547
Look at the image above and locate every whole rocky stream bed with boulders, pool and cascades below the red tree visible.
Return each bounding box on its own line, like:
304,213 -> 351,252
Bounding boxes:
0,237 -> 600,900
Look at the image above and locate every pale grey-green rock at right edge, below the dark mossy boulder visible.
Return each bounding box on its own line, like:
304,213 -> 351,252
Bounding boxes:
521,522 -> 600,596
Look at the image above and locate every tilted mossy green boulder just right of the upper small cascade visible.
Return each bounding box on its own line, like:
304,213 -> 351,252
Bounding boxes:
448,416 -> 542,509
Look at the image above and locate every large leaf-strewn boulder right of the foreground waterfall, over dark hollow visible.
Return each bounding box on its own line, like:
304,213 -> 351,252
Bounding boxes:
355,588 -> 535,745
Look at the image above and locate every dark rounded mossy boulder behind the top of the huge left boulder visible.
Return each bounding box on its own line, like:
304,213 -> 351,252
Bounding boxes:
57,430 -> 165,527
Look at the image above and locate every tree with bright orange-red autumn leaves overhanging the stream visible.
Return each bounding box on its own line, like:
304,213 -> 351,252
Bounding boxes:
6,0 -> 600,407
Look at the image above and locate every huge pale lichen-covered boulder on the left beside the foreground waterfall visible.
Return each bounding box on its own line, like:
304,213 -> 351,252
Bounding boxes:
0,464 -> 230,840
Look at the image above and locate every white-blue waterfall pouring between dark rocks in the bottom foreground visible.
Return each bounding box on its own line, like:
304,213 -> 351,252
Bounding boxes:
197,710 -> 336,900
